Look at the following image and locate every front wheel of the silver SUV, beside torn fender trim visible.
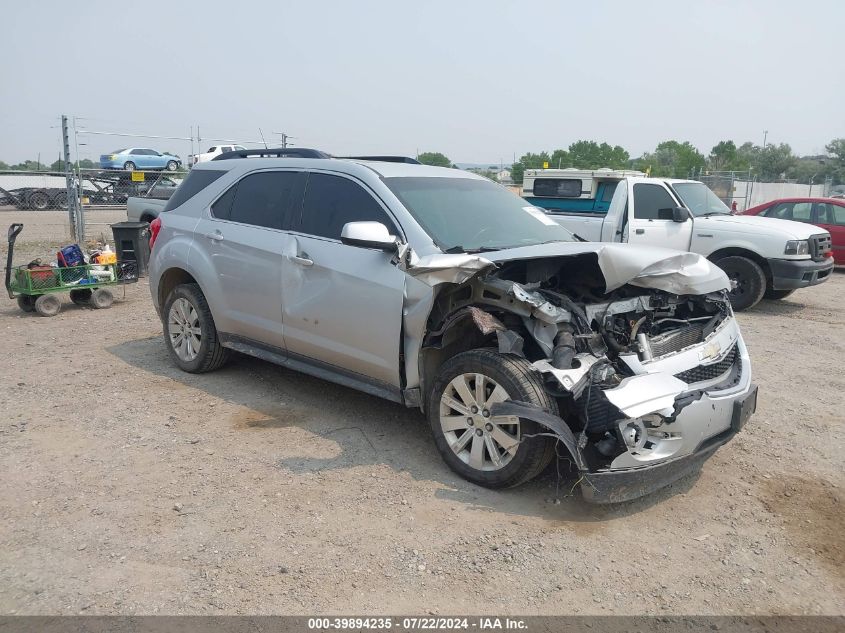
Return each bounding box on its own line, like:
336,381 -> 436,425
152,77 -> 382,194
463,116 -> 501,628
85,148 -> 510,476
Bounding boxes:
428,349 -> 557,488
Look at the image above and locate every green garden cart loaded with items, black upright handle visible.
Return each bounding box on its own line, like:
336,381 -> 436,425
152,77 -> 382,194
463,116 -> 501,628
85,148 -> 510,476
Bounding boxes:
6,223 -> 138,316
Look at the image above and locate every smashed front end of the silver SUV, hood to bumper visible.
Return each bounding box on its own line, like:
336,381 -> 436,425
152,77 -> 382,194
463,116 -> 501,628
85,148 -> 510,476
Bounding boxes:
408,245 -> 756,503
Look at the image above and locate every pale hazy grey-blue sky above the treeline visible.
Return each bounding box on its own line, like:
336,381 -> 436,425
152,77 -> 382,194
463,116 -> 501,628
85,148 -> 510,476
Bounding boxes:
0,0 -> 845,164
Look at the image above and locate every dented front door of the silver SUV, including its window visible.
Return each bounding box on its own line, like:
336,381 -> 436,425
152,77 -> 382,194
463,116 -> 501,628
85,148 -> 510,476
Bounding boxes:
282,172 -> 405,387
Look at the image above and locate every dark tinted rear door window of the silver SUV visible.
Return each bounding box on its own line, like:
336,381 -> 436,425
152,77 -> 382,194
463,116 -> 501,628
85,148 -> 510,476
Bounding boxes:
216,171 -> 299,229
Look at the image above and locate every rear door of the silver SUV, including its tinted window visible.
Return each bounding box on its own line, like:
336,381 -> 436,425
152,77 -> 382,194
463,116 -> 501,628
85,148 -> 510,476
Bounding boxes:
196,170 -> 305,350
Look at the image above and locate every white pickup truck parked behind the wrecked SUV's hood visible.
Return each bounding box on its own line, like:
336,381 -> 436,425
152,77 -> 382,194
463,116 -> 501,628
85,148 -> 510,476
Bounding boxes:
524,170 -> 833,311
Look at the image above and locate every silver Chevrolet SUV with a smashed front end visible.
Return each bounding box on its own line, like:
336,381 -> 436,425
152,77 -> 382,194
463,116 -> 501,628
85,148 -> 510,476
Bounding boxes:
150,150 -> 757,503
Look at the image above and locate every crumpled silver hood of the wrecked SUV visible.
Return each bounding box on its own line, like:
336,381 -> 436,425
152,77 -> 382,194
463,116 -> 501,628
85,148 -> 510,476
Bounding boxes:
406,242 -> 730,295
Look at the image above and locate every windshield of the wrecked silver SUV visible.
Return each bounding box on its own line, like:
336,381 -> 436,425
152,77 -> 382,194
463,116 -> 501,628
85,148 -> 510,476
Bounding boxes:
384,178 -> 575,252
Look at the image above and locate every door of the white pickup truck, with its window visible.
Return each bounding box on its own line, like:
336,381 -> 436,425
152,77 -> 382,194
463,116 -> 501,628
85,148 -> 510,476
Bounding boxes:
628,182 -> 693,251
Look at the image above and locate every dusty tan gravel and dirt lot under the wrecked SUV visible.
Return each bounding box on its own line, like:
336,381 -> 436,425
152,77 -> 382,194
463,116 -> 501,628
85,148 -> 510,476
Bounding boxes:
0,212 -> 845,614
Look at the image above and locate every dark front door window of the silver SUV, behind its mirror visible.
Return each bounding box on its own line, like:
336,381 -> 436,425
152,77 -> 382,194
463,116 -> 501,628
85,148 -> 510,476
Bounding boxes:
299,174 -> 398,240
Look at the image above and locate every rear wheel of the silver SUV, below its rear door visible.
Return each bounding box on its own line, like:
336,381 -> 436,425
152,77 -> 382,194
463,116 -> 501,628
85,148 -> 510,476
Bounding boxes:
163,284 -> 229,374
